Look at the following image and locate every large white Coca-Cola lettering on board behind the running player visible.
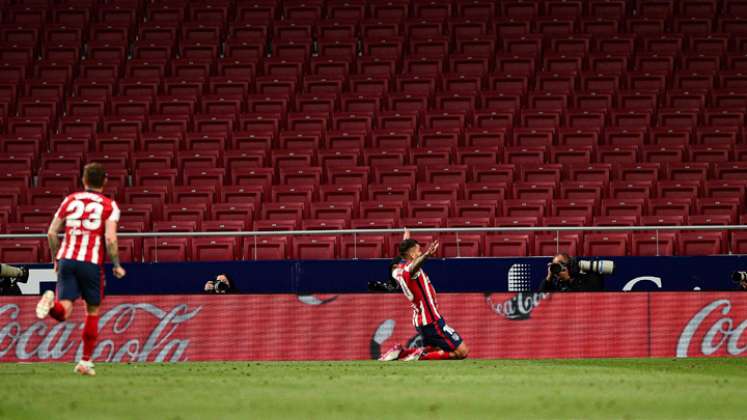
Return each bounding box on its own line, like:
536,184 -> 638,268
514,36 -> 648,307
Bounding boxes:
0,303 -> 202,362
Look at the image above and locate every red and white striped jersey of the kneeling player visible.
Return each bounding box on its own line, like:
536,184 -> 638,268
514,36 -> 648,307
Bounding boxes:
392,260 -> 441,327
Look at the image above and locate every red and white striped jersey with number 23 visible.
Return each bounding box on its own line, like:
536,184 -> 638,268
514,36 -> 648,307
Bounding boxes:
55,191 -> 119,265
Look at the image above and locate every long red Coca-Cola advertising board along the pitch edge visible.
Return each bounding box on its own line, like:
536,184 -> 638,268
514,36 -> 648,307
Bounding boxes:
0,292 -> 747,362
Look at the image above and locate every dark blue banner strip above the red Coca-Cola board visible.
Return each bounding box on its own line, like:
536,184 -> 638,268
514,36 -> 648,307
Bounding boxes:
22,255 -> 747,294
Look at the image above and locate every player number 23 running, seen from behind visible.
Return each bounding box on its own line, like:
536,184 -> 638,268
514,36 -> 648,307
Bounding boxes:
36,163 -> 126,376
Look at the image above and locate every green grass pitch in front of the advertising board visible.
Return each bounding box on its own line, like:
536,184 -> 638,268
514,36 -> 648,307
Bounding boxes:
0,359 -> 747,419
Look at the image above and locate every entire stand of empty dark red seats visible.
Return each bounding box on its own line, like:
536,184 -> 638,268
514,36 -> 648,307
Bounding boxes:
0,0 -> 747,262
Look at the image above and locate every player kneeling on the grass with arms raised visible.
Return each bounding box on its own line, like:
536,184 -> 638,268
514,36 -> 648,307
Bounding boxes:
379,230 -> 469,361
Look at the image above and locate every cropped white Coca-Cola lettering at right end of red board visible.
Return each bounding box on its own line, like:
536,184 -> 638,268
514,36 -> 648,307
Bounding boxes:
677,299 -> 747,357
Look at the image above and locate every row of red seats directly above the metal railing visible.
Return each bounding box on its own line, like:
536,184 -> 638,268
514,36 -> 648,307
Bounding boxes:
0,199 -> 747,228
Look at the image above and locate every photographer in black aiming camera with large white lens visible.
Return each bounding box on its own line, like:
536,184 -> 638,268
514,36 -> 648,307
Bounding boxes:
540,254 -> 614,292
